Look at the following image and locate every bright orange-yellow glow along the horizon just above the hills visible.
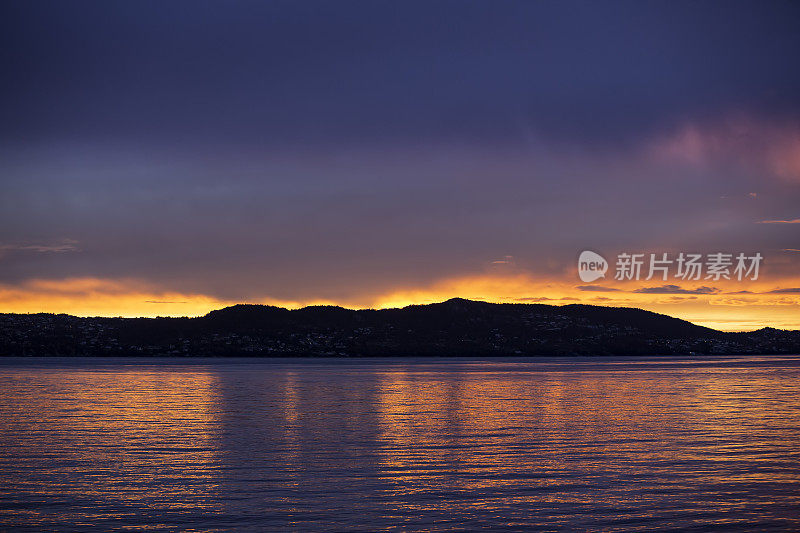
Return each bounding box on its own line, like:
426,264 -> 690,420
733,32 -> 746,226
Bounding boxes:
0,274 -> 800,331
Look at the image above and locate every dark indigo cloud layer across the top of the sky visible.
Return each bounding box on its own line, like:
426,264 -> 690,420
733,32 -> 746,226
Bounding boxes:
0,0 -> 800,145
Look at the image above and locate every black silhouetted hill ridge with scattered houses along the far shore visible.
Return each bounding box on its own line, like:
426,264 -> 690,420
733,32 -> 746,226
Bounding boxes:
0,298 -> 800,356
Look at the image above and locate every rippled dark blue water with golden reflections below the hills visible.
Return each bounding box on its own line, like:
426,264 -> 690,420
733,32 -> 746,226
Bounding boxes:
0,357 -> 800,531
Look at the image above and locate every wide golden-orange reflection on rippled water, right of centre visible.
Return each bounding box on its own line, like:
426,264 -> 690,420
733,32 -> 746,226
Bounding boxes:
378,360 -> 800,525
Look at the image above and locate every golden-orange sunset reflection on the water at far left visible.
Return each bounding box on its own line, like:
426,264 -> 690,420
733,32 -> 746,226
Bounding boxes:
0,369 -> 225,527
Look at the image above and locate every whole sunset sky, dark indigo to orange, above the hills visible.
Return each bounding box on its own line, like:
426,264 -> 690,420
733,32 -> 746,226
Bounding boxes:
0,0 -> 800,330
